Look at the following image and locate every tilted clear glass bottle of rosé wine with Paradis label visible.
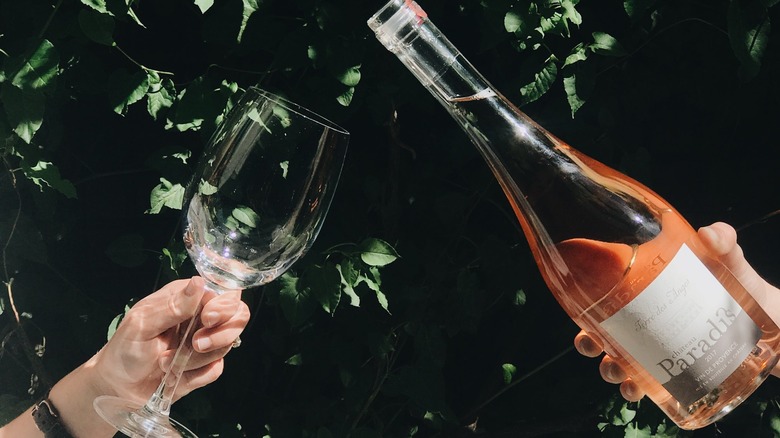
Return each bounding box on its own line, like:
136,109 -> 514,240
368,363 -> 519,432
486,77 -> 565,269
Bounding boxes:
368,0 -> 780,429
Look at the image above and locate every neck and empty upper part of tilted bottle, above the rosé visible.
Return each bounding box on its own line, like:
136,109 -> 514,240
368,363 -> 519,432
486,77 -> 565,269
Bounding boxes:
368,0 -> 663,247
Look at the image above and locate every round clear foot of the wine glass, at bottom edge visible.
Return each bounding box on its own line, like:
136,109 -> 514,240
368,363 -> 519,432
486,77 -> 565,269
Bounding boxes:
93,396 -> 198,438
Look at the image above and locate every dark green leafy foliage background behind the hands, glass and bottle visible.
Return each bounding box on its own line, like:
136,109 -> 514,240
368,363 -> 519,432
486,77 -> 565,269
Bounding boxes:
0,0 -> 780,438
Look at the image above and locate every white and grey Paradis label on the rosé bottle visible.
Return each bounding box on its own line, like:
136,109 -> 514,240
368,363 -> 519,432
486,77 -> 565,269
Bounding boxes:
601,245 -> 761,406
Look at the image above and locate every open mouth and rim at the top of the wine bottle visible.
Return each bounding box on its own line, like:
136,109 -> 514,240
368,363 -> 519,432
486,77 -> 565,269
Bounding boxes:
367,0 -> 428,52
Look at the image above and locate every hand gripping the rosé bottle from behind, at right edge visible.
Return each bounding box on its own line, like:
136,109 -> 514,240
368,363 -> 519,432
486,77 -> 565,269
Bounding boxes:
574,222 -> 780,401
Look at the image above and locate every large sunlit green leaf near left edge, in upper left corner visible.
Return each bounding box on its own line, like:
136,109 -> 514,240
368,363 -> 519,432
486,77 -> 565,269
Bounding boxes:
10,40 -> 59,91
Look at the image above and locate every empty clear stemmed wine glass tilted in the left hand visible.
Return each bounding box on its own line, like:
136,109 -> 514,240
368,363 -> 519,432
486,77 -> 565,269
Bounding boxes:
94,87 -> 349,438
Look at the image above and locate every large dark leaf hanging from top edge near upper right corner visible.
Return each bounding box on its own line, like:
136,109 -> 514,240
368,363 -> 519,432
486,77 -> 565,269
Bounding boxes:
728,0 -> 770,82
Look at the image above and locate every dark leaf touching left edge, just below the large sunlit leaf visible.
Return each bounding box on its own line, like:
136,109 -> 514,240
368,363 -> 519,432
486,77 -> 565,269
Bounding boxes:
0,82 -> 46,144
